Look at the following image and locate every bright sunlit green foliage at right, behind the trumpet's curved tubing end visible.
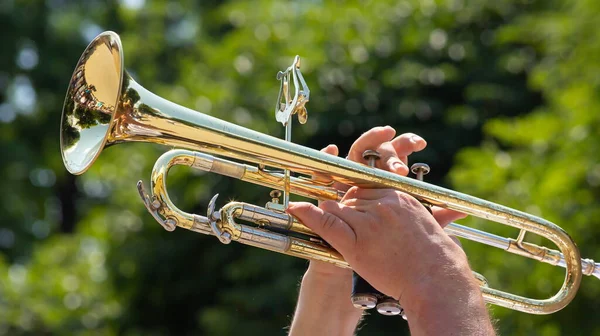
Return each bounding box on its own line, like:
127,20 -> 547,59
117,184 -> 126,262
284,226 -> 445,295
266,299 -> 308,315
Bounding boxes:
451,1 -> 600,335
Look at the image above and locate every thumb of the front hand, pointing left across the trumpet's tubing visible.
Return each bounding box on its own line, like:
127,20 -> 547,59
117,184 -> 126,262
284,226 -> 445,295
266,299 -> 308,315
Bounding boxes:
287,201 -> 356,255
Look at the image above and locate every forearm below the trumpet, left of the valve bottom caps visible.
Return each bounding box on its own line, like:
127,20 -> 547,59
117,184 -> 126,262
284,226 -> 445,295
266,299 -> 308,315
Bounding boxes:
290,264 -> 362,336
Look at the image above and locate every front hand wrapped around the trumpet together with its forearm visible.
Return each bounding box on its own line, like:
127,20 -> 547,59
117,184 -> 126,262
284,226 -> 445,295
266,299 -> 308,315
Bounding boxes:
287,187 -> 493,335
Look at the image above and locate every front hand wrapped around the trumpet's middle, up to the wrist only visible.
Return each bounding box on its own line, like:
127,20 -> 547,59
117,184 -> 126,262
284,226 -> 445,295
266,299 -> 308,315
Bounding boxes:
288,187 -> 466,298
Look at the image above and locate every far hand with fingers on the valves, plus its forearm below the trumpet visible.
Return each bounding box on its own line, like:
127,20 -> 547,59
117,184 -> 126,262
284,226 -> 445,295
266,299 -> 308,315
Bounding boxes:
290,126 -> 434,336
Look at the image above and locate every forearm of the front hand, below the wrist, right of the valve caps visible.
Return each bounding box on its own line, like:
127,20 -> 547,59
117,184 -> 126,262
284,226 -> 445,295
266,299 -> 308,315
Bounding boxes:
401,243 -> 495,336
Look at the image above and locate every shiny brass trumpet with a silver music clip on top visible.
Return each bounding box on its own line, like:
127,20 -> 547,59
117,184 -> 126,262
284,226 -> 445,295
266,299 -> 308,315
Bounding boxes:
60,32 -> 600,314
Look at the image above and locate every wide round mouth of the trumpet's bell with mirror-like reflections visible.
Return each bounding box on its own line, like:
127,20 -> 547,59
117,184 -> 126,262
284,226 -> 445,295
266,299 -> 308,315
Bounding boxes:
60,31 -> 124,175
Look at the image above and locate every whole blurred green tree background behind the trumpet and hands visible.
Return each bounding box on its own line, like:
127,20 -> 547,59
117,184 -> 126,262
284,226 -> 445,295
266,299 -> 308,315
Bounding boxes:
0,0 -> 600,335
